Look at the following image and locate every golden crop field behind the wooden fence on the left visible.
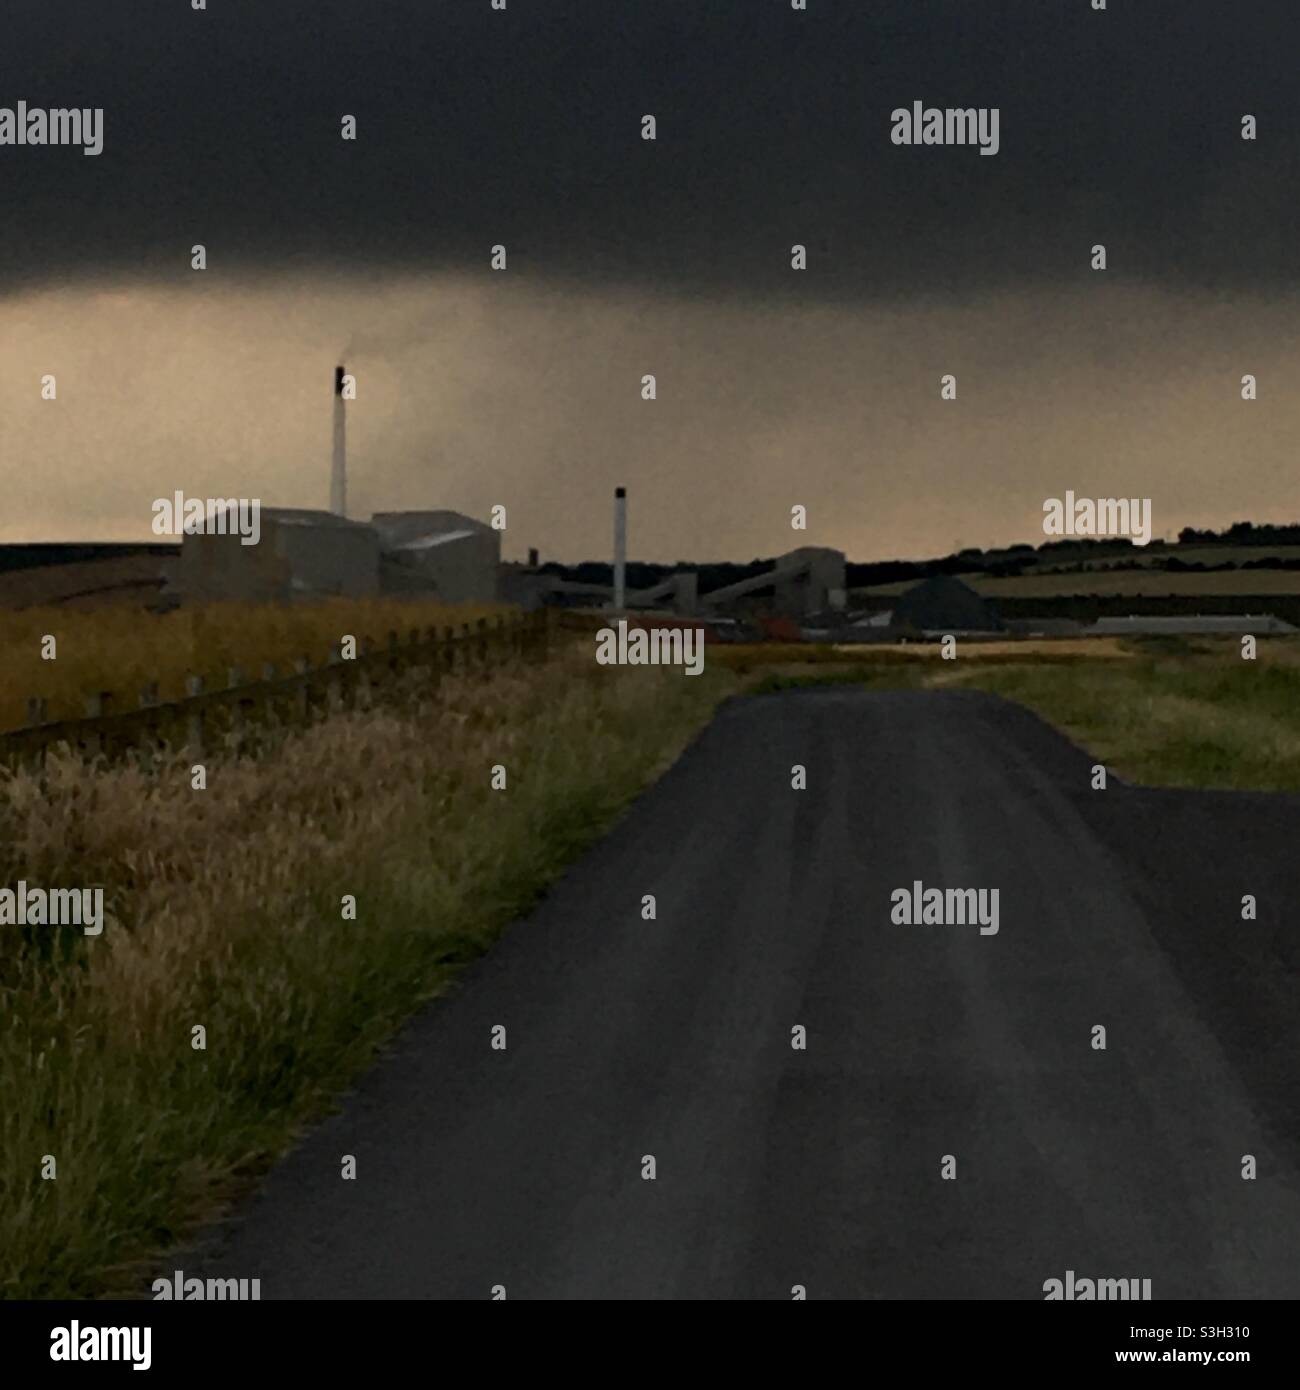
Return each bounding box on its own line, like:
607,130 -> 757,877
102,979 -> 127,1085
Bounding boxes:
0,599 -> 514,730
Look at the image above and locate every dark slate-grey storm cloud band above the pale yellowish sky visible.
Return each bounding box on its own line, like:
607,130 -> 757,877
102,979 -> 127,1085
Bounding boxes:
0,0 -> 1300,297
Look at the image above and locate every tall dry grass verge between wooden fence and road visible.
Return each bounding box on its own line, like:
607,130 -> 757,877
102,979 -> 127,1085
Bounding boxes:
0,649 -> 734,1297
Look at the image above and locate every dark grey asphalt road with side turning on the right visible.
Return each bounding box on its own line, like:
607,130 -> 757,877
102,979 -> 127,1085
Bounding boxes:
187,689 -> 1300,1300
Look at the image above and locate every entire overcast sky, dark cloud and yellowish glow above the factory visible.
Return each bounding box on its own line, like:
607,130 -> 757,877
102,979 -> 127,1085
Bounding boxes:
0,0 -> 1300,560
